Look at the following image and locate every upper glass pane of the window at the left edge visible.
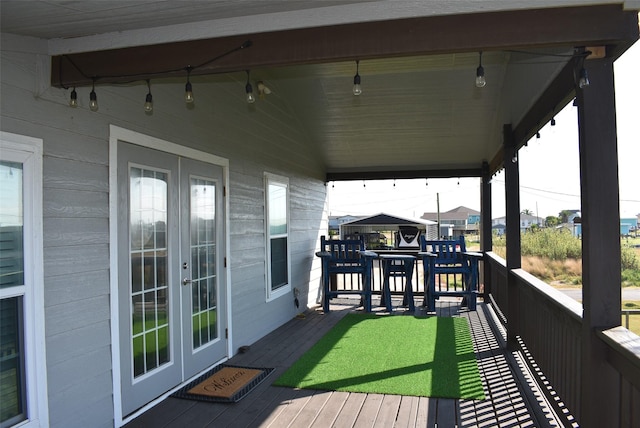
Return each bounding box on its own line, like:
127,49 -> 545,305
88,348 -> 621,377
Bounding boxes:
0,161 -> 24,288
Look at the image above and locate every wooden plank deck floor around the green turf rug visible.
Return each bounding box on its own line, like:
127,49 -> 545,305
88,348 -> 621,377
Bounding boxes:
126,299 -> 560,428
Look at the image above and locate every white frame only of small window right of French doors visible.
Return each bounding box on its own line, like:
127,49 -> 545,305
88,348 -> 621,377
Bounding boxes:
264,172 -> 291,302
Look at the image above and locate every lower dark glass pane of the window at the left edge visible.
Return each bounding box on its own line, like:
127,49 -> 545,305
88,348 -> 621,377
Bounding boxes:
0,297 -> 26,426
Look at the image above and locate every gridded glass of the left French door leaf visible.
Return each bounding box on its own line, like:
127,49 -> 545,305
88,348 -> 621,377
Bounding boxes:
129,167 -> 171,376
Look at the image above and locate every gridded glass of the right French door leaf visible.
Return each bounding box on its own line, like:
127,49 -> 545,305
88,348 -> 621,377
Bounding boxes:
189,178 -> 218,349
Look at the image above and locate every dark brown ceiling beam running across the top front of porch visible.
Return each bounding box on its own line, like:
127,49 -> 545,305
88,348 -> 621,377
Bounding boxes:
51,5 -> 638,87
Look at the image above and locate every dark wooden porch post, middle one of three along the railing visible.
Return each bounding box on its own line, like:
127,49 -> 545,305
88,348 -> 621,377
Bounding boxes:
503,125 -> 522,349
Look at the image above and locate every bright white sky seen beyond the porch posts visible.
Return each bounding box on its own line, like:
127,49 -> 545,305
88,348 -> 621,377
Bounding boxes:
328,42 -> 640,218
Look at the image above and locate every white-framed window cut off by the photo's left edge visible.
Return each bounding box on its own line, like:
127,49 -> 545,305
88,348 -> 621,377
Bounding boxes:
0,132 -> 48,428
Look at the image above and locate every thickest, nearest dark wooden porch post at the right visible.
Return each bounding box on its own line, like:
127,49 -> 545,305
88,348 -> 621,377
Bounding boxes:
576,58 -> 621,428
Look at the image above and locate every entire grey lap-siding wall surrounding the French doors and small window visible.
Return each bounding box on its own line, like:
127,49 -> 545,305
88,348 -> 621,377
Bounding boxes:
0,42 -> 326,427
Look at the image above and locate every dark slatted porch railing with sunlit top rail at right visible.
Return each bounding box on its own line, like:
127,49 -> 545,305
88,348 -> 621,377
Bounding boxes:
484,253 -> 640,426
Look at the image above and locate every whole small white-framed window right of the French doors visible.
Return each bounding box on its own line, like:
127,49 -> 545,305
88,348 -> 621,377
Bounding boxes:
265,174 -> 291,300
